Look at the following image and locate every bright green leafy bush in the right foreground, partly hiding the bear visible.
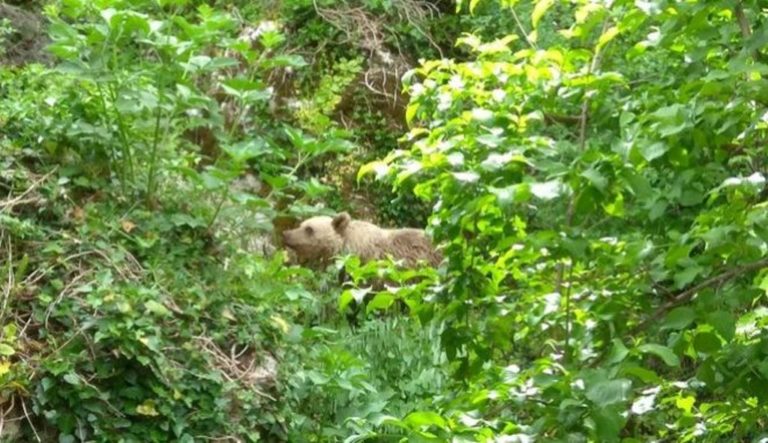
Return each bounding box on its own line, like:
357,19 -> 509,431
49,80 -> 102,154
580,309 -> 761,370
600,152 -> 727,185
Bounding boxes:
362,1 -> 766,441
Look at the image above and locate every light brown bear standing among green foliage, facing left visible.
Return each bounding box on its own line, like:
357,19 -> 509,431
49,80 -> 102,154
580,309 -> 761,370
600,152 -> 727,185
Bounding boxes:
283,212 -> 442,267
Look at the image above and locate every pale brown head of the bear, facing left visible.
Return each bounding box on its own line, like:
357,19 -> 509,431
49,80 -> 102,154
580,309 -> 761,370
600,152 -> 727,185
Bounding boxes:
283,212 -> 352,263
